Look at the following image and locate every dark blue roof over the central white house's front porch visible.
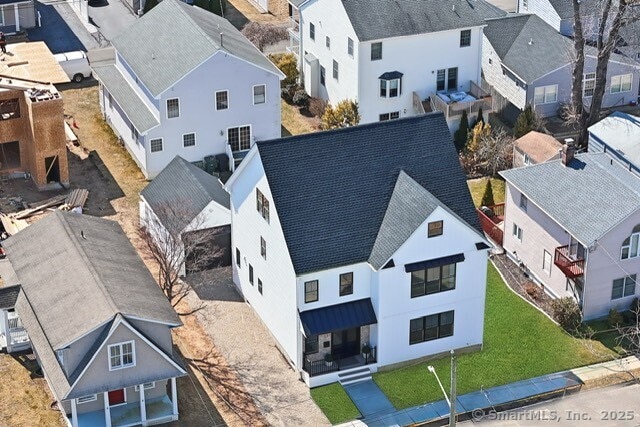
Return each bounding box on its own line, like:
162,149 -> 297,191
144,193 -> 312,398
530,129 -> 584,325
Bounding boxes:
300,298 -> 378,336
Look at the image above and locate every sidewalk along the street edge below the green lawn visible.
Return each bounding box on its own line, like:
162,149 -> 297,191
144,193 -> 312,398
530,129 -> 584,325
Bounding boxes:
339,356 -> 640,427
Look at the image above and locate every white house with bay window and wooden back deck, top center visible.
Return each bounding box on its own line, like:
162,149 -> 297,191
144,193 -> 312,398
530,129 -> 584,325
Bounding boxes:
289,0 -> 505,129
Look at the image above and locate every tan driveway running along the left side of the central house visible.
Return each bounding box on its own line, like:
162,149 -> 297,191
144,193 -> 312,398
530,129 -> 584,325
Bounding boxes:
182,267 -> 330,426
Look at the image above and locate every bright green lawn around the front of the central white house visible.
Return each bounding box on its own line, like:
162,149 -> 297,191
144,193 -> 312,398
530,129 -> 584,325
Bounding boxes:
312,264 -> 613,423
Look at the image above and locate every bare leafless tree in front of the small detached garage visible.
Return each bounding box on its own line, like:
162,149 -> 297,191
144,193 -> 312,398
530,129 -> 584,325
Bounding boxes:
138,201 -> 225,315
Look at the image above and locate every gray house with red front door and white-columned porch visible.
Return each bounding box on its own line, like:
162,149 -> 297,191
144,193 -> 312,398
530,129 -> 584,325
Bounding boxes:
3,211 -> 186,427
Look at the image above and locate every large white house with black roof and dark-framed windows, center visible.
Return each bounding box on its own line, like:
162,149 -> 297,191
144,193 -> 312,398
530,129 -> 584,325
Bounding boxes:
225,113 -> 488,387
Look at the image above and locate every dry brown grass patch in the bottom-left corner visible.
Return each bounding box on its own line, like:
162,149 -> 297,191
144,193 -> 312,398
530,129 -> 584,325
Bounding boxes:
0,352 -> 66,427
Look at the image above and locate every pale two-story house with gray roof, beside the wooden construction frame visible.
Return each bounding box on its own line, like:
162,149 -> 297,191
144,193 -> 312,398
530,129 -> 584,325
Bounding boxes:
93,0 -> 283,179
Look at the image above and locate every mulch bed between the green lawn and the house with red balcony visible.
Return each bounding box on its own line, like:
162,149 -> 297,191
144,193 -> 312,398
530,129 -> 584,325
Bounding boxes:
491,254 -> 553,316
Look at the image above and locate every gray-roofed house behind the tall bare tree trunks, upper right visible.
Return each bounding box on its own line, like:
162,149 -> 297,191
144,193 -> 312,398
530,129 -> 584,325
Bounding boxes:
482,14 -> 640,117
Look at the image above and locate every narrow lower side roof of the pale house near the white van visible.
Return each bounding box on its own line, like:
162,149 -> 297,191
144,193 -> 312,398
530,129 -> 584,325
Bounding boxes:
93,64 -> 160,133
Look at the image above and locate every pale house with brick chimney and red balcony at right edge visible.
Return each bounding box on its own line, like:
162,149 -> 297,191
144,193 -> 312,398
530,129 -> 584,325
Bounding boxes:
500,147 -> 640,320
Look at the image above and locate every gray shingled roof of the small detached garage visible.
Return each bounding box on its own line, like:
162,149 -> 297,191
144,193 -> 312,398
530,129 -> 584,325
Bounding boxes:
140,156 -> 230,230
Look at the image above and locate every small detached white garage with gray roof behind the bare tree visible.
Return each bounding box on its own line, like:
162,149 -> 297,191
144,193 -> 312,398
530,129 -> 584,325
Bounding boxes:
140,156 -> 231,276
